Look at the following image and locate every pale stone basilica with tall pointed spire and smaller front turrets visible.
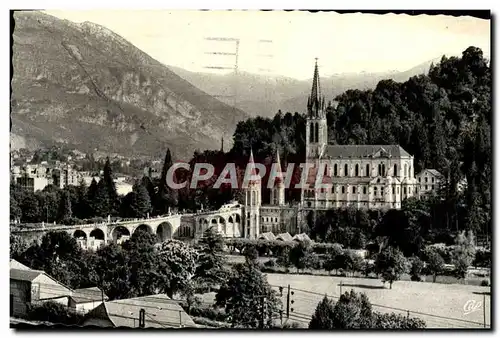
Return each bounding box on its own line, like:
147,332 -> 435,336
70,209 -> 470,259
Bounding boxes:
243,61 -> 441,238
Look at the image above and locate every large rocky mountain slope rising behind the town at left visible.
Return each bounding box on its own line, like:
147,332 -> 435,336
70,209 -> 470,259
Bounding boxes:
11,12 -> 248,159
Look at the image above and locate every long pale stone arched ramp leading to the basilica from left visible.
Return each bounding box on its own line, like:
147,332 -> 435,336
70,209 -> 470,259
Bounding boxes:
11,208 -> 243,248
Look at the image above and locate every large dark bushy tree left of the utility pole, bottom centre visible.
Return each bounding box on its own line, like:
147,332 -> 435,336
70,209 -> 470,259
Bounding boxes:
215,264 -> 280,328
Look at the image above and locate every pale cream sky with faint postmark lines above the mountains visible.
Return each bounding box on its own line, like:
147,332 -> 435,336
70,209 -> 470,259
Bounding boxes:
45,10 -> 491,80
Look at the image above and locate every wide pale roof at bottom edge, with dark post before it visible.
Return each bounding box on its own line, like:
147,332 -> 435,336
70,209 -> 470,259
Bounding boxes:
83,294 -> 197,329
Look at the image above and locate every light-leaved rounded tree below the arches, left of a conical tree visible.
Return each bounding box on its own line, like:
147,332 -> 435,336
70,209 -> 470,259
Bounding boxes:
157,240 -> 198,297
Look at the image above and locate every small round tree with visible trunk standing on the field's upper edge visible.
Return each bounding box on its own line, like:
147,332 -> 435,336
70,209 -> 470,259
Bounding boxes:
375,247 -> 407,289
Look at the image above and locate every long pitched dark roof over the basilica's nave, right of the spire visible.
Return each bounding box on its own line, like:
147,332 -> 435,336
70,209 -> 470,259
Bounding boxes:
323,144 -> 410,159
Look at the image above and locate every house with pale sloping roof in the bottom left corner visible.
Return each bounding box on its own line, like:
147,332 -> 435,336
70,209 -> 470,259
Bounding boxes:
10,262 -> 72,317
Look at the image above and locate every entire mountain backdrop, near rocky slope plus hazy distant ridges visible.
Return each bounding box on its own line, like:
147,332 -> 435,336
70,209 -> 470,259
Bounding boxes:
10,11 -> 480,160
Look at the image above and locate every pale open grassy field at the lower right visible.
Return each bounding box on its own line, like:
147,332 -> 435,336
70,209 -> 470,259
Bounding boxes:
202,262 -> 491,328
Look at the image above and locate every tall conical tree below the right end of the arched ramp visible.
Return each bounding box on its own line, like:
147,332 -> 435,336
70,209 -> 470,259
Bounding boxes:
194,227 -> 227,288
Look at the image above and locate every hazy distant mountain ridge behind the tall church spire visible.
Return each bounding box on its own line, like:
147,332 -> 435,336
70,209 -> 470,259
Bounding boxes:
169,57 -> 441,117
